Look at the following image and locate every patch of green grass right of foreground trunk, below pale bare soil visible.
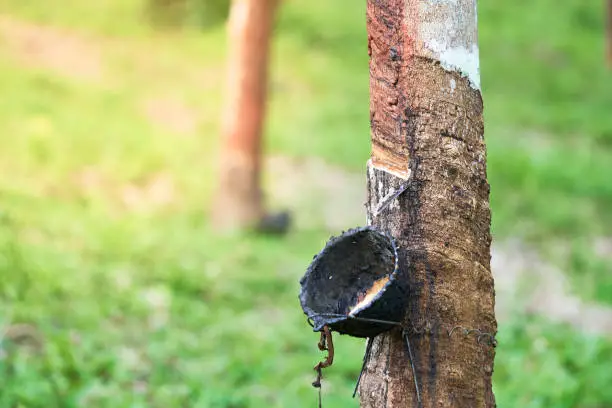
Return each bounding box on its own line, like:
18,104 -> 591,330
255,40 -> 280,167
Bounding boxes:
493,316 -> 612,408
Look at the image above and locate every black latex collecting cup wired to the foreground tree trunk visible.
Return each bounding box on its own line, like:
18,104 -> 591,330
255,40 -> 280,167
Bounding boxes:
300,227 -> 407,337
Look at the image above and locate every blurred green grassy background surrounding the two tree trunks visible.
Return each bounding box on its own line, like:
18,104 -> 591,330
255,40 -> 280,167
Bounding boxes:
0,0 -> 612,408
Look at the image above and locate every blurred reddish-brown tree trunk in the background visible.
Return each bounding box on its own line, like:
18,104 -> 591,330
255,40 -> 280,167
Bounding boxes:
213,0 -> 277,229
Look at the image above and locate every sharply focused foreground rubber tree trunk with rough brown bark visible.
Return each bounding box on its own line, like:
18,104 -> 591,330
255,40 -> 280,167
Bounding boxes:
359,0 -> 497,408
